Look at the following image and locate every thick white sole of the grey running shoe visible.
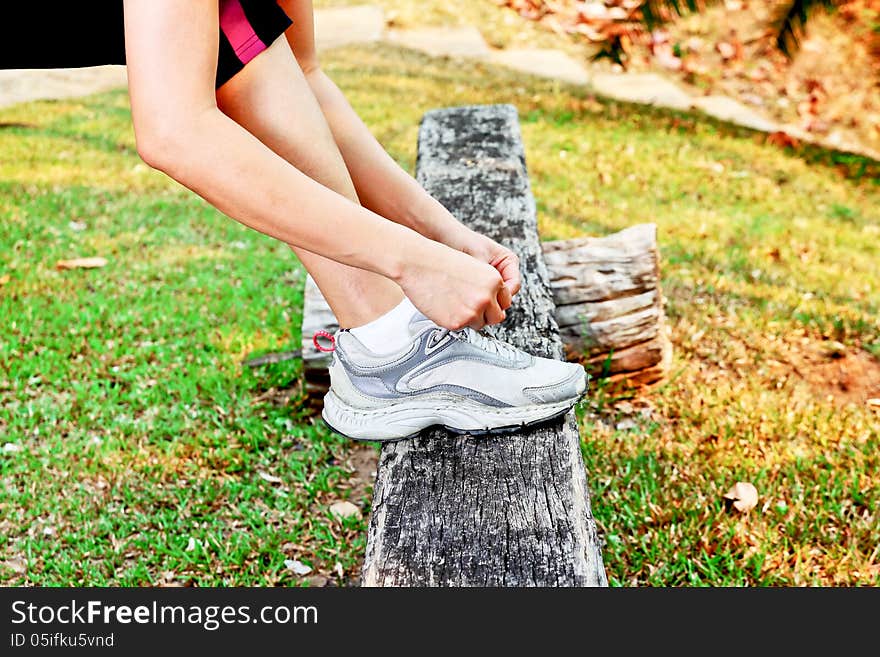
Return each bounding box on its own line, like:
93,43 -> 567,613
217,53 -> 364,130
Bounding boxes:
321,390 -> 586,443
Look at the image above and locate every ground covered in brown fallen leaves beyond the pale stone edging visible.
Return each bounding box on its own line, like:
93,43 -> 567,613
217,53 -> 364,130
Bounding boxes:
493,0 -> 880,153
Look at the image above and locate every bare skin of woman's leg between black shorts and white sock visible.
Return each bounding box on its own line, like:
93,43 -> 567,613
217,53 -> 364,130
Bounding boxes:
217,36 -> 403,327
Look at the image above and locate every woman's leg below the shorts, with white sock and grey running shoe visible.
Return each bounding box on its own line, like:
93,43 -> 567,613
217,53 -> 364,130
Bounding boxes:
217,30 -> 587,440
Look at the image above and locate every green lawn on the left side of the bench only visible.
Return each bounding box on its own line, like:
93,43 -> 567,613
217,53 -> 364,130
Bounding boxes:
0,92 -> 365,585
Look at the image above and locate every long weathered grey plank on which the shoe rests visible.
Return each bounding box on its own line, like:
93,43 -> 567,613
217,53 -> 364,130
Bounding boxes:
362,105 -> 607,586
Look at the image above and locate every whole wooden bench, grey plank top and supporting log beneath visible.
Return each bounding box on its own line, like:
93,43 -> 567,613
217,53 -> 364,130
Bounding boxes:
302,105 -> 668,586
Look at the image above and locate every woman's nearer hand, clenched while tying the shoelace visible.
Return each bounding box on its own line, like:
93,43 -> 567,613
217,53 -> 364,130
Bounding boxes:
397,239 -> 510,330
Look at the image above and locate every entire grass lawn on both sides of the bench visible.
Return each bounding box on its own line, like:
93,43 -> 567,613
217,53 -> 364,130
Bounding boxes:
0,46 -> 880,586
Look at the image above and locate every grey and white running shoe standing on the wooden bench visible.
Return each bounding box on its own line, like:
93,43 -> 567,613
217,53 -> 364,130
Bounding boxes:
323,313 -> 589,441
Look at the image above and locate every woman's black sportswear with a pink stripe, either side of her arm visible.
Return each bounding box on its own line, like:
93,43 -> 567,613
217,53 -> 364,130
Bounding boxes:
0,0 -> 291,87
